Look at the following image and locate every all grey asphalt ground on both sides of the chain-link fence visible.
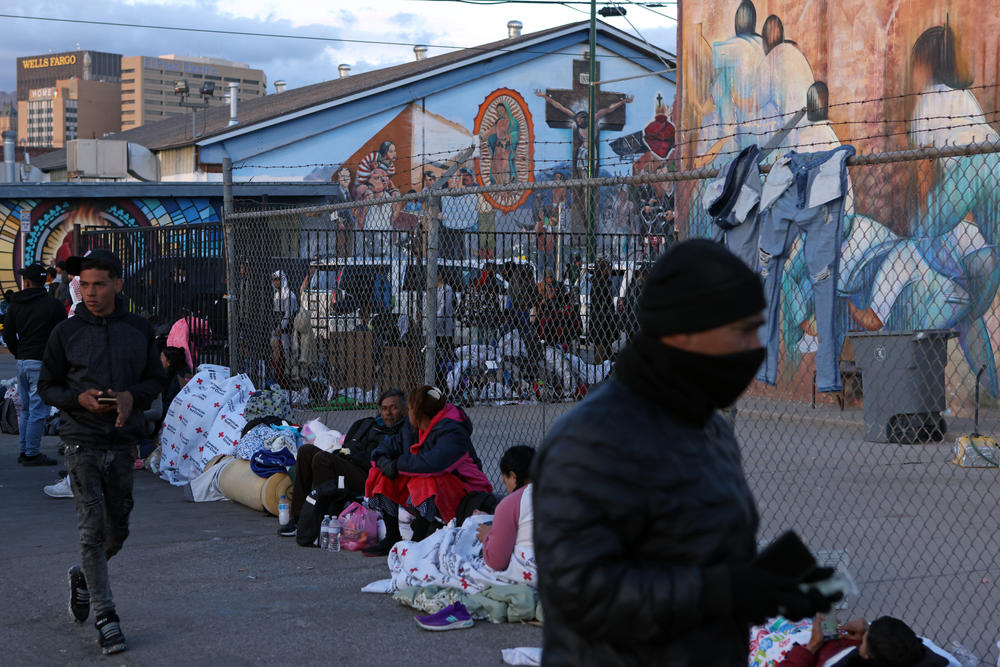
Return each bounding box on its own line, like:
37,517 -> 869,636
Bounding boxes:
0,344 -> 1000,665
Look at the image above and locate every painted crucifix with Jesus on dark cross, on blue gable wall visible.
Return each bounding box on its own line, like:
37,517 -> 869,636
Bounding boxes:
535,59 -> 633,178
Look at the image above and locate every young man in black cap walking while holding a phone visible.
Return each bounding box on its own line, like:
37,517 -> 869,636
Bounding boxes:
38,250 -> 165,655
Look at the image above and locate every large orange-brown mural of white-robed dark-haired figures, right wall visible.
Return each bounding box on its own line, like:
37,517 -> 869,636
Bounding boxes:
678,0 -> 1000,396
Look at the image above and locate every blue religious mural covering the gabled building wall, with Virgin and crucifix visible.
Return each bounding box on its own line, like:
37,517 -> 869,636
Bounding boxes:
237,48 -> 676,258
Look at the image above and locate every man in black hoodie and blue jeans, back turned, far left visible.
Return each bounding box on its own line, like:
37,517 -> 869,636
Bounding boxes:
3,263 -> 66,466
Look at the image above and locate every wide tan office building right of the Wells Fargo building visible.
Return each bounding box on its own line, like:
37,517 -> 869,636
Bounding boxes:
121,55 -> 267,130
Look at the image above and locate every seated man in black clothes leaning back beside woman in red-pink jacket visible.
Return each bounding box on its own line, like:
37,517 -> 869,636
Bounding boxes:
278,389 -> 406,536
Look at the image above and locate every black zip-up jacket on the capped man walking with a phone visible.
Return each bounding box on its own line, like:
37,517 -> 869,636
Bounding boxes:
38,297 -> 166,448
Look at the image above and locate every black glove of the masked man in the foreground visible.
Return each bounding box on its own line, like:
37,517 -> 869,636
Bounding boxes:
729,563 -> 841,625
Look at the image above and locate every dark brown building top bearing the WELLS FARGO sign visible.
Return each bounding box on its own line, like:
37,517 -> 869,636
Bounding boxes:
17,50 -> 122,102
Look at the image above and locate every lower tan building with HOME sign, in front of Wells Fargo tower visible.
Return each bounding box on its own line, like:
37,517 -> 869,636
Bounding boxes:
17,79 -> 121,148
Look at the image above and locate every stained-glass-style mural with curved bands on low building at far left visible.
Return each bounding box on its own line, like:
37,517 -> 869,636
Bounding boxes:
0,197 -> 222,291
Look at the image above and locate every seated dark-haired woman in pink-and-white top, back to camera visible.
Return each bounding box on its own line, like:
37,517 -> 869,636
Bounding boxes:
476,445 -> 535,571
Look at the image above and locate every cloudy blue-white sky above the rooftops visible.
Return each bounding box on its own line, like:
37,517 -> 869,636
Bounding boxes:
0,0 -> 677,92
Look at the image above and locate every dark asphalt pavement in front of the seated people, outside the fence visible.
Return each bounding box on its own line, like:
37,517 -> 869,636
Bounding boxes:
0,430 -> 542,665
